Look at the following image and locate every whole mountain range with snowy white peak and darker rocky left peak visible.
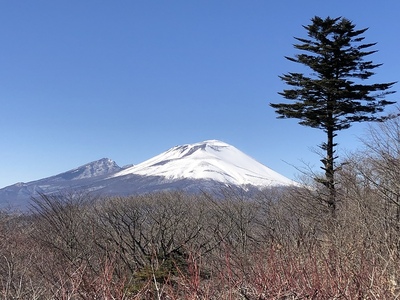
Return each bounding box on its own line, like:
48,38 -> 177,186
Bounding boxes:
0,140 -> 296,209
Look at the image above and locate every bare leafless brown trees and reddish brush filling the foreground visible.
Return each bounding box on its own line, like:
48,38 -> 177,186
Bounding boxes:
0,119 -> 400,300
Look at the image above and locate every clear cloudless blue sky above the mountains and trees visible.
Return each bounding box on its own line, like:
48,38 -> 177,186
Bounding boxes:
0,0 -> 400,187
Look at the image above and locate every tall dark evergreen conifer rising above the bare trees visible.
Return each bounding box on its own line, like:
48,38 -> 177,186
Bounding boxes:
270,17 -> 395,215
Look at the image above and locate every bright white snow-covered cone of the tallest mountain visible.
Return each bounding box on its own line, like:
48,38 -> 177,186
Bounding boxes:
111,140 -> 295,187
